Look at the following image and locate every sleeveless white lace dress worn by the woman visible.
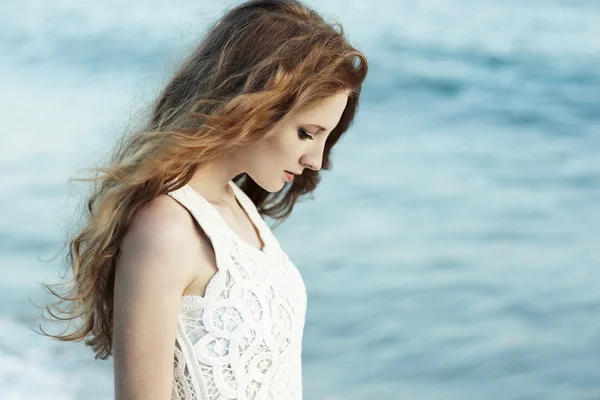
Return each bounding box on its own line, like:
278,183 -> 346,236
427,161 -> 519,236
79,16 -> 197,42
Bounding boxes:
169,181 -> 306,400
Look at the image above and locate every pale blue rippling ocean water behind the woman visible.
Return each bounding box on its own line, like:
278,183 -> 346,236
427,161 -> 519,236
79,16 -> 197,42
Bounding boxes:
0,0 -> 600,400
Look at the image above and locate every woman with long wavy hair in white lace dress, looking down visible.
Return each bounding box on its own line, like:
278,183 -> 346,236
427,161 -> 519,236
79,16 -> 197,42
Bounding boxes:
41,0 -> 367,400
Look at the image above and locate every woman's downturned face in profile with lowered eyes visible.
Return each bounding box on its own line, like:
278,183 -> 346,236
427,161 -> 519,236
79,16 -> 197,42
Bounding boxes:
245,91 -> 349,193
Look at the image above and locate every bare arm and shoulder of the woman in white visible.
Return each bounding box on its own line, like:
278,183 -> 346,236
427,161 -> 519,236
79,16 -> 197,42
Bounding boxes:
113,195 -> 214,400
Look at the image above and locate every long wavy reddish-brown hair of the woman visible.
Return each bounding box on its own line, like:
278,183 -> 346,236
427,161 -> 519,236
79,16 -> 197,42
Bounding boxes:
40,0 -> 367,359
